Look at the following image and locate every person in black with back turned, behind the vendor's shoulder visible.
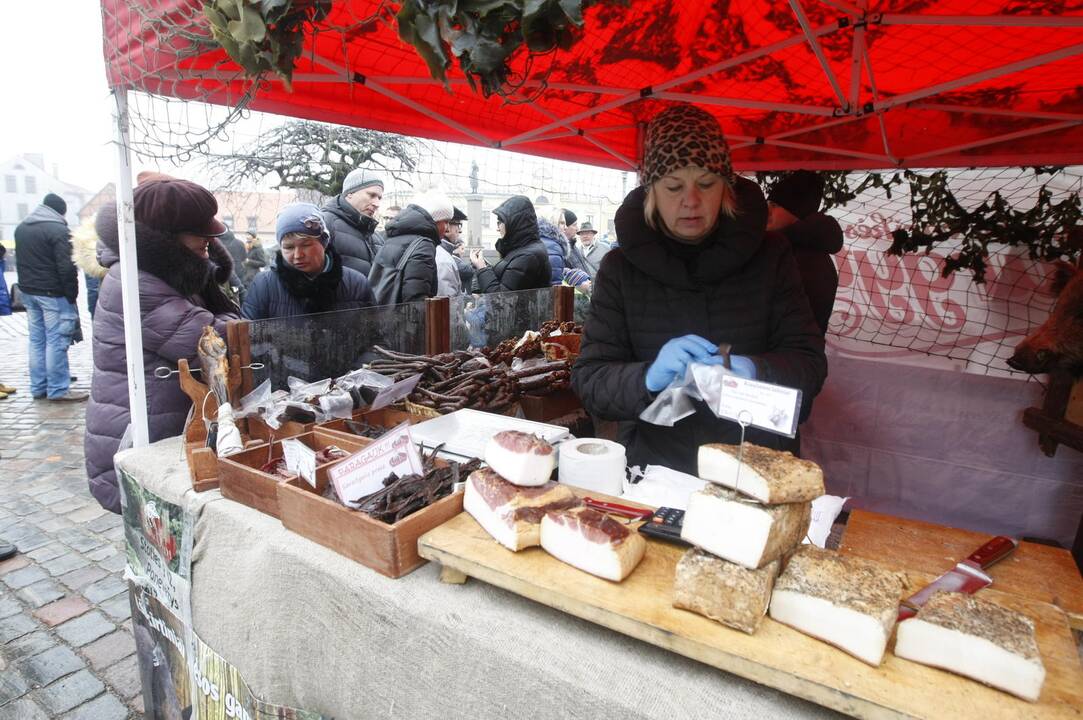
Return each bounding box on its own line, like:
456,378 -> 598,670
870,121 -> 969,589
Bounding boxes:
767,170 -> 843,335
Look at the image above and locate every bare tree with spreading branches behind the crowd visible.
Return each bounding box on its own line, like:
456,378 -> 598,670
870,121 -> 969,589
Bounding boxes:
213,120 -> 422,197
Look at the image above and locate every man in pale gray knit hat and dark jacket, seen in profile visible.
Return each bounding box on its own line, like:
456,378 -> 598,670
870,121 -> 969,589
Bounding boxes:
323,168 -> 383,277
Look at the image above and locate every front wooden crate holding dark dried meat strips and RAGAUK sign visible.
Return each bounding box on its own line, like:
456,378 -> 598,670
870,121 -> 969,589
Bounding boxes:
277,472 -> 462,578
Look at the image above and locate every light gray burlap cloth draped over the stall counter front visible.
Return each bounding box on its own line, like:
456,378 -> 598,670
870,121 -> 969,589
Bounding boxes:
117,440 -> 840,720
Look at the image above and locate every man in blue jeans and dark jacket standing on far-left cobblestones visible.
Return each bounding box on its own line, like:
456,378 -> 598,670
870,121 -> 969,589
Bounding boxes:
15,193 -> 87,401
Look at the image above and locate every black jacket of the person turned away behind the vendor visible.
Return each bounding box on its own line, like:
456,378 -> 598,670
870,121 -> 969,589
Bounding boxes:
782,212 -> 843,333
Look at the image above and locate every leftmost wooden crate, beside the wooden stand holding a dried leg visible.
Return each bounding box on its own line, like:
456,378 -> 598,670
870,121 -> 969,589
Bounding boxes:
218,429 -> 371,518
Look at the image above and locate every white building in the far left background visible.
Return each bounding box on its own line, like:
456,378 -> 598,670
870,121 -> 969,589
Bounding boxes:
0,154 -> 94,242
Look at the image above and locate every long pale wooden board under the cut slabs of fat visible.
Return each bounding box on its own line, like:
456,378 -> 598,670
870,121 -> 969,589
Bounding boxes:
418,500 -> 1083,720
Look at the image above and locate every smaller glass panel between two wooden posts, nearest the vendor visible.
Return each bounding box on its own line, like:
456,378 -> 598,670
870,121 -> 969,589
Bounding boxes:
451,287 -> 552,350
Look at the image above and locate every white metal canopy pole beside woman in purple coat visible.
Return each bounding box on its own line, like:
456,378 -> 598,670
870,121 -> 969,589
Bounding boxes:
113,88 -> 151,447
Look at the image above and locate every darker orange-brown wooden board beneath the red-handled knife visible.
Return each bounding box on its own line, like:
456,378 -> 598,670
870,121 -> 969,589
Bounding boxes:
839,510 -> 1083,630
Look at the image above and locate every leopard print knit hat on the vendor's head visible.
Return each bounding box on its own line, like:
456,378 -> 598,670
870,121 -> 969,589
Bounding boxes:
640,103 -> 736,185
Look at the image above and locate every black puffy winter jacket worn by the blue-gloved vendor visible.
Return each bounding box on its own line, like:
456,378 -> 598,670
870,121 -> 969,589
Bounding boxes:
572,179 -> 827,474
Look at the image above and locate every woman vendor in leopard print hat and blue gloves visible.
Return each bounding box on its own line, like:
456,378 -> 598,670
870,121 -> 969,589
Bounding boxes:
572,104 -> 827,474
